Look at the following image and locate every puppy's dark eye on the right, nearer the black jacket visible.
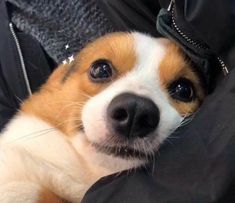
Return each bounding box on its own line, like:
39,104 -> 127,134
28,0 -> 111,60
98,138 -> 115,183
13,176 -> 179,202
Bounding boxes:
168,78 -> 196,102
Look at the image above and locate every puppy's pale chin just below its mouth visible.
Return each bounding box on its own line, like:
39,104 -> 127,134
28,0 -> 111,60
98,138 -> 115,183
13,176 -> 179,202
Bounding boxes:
71,131 -> 147,175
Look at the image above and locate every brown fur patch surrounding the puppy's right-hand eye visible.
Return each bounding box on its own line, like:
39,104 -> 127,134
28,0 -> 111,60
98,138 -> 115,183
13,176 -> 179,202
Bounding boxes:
159,43 -> 205,115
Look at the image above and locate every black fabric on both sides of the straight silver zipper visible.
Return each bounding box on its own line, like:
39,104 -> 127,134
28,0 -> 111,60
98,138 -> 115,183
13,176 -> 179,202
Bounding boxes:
0,1 -> 55,131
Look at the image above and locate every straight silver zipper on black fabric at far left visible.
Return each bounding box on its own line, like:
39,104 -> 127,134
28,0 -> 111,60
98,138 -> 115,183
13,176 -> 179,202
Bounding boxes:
9,23 -> 32,95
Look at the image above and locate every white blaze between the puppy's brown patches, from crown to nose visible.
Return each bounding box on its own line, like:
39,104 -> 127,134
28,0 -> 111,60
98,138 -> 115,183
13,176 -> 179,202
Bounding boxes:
112,32 -> 169,96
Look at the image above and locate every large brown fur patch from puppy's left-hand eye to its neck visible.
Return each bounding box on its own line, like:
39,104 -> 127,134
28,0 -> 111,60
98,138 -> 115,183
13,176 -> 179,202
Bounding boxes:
21,33 -> 136,135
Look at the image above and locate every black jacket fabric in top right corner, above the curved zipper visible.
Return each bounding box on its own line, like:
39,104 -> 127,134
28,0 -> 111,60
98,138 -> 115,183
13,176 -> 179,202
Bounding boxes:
159,0 -> 235,68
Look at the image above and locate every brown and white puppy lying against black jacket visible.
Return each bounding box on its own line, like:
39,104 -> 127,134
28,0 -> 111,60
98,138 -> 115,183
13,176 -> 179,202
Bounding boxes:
0,33 -> 204,203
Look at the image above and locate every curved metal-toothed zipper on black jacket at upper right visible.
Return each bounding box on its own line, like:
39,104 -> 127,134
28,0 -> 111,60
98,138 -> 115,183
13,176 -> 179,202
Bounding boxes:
167,0 -> 229,76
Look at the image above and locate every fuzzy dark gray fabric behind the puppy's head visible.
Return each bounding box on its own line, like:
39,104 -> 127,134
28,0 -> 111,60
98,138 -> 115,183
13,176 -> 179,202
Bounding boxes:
8,0 -> 113,63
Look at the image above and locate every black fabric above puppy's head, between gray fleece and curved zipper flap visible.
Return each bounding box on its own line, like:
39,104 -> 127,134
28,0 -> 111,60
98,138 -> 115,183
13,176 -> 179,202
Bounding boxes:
98,0 -> 161,37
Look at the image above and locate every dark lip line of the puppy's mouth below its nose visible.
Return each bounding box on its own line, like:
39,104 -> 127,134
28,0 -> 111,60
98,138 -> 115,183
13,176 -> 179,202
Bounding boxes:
92,143 -> 152,160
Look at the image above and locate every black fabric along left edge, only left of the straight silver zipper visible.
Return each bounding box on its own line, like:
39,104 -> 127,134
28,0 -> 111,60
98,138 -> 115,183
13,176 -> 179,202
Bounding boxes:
0,1 -> 23,129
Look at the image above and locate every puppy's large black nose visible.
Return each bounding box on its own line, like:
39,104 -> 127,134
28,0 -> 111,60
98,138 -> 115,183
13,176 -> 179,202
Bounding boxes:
107,93 -> 160,138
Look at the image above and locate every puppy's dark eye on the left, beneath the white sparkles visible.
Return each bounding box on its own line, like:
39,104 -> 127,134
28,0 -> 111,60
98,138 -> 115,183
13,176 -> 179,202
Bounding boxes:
89,60 -> 114,82
